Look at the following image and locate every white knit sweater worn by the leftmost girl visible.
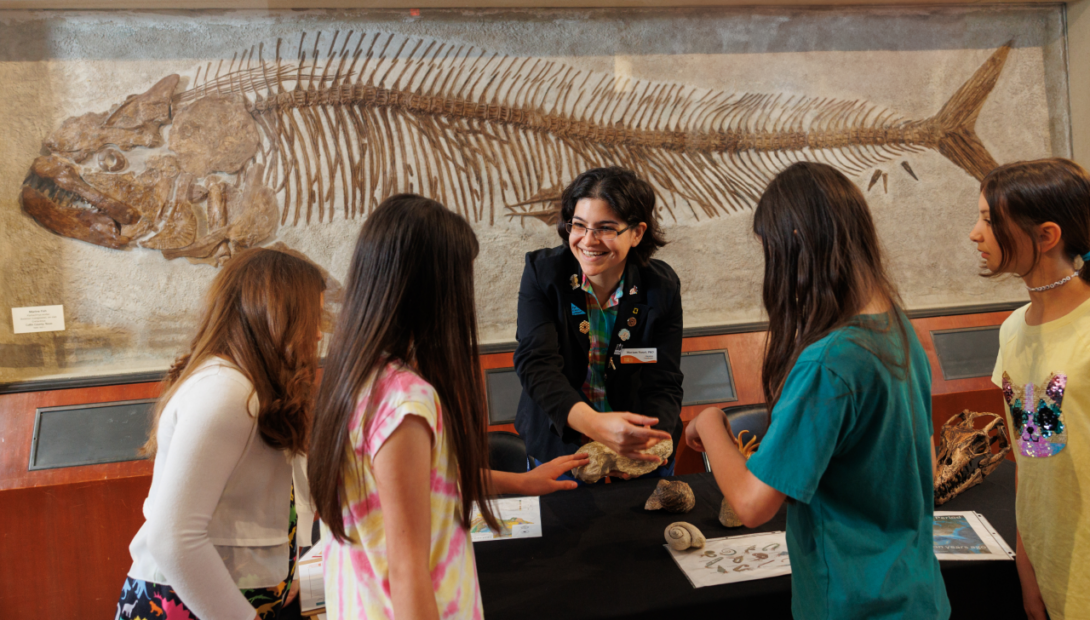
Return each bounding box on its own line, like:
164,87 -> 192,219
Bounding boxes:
129,357 -> 294,620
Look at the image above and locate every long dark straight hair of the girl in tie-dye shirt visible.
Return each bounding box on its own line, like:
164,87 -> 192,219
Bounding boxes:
307,194 -> 498,540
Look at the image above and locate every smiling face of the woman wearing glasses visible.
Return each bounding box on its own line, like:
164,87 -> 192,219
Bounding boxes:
568,198 -> 647,278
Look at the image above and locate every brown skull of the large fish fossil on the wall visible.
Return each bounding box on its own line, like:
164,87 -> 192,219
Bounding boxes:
21,75 -> 280,264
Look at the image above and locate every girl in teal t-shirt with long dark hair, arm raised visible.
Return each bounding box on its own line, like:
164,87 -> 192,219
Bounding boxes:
686,162 -> 949,620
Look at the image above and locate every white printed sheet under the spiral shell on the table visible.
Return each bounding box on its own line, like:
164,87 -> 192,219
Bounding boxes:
664,532 -> 791,587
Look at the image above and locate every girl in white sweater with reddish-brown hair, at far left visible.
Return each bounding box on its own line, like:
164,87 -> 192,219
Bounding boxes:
117,250 -> 325,620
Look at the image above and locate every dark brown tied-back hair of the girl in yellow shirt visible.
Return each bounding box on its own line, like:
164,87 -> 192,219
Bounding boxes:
980,157 -> 1090,283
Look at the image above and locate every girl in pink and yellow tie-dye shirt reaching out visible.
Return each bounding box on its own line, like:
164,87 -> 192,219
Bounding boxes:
307,194 -> 586,619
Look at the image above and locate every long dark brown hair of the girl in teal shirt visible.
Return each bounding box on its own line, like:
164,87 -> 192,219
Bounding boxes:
753,161 -> 909,411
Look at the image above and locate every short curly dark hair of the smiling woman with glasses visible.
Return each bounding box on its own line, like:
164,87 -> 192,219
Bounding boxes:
556,166 -> 666,267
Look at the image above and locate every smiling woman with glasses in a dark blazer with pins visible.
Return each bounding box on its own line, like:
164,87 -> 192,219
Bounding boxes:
514,168 -> 681,475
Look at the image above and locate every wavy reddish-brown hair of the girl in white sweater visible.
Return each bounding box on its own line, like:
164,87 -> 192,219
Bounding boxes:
142,248 -> 325,457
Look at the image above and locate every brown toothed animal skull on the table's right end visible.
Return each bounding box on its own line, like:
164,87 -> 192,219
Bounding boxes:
935,410 -> 1010,506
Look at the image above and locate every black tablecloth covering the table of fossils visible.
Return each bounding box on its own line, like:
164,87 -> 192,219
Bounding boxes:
473,462 -> 1025,620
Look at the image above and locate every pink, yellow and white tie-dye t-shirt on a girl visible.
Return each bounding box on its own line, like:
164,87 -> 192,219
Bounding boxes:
322,363 -> 482,620
